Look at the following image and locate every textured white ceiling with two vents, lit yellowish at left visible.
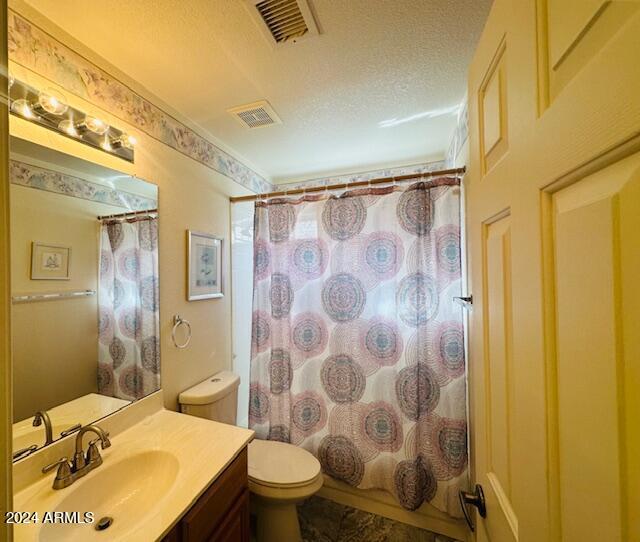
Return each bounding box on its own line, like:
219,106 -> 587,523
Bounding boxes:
20,0 -> 491,182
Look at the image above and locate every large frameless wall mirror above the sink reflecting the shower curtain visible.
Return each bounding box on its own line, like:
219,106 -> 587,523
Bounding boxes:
10,137 -> 160,461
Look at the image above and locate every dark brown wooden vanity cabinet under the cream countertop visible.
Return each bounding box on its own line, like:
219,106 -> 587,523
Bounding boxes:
163,448 -> 250,542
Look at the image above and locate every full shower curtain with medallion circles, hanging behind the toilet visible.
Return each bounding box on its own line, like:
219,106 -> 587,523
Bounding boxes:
249,178 -> 468,516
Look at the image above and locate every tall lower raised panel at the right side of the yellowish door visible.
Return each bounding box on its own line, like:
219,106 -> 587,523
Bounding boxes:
549,182 -> 620,541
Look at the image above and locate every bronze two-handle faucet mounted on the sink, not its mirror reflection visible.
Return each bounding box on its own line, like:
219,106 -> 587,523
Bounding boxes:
42,425 -> 111,489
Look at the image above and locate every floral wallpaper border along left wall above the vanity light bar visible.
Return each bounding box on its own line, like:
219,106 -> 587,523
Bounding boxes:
8,11 -> 272,196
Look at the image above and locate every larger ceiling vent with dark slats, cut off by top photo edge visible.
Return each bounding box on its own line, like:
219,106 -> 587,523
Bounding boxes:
248,0 -> 318,44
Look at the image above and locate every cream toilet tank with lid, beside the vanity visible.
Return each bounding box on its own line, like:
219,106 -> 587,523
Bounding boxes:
178,371 -> 240,425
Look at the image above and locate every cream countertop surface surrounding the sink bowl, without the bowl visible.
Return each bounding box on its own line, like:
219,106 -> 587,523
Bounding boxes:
14,410 -> 254,542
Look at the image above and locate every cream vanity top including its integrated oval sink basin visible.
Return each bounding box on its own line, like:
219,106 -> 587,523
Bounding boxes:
13,410 -> 253,542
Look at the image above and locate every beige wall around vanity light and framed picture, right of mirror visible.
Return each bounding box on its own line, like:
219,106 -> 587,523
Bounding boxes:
10,5 -> 247,409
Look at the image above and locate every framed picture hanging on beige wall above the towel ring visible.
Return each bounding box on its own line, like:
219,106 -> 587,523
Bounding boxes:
187,230 -> 224,301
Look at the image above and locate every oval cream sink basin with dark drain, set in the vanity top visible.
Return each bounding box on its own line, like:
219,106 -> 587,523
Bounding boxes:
40,450 -> 179,542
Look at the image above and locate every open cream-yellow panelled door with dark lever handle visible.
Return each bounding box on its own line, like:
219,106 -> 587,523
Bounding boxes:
465,0 -> 640,542
